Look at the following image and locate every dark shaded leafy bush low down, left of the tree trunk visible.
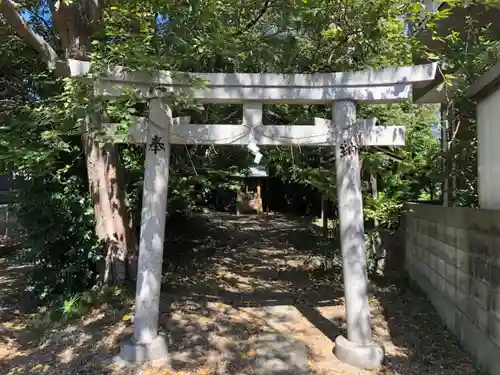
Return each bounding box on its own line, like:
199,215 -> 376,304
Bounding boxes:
16,173 -> 102,298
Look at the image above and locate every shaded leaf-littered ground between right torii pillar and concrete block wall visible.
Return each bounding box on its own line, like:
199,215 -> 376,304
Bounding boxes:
375,284 -> 484,375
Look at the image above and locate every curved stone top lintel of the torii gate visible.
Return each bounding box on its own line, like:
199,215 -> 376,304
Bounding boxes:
69,60 -> 437,104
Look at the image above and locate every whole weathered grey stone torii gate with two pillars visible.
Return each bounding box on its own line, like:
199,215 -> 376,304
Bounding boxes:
70,60 -> 437,368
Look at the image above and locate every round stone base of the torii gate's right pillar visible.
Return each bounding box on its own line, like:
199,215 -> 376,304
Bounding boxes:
335,336 -> 384,370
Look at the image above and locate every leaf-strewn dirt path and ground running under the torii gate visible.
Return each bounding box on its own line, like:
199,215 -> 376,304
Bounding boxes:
0,215 -> 479,375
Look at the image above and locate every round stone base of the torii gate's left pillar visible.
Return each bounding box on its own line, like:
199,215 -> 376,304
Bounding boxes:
120,334 -> 169,363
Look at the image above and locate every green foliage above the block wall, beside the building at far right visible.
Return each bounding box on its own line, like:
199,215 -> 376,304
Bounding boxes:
420,0 -> 500,207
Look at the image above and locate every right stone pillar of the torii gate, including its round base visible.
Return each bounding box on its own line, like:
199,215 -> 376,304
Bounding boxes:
332,100 -> 384,369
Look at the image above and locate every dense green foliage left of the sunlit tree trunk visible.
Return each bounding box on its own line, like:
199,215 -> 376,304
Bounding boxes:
0,20 -> 101,298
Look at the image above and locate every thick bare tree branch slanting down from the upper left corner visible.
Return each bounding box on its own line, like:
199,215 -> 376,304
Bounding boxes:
0,0 -> 68,75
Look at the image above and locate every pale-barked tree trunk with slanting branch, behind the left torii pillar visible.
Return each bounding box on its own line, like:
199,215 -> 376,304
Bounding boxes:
0,0 -> 138,284
